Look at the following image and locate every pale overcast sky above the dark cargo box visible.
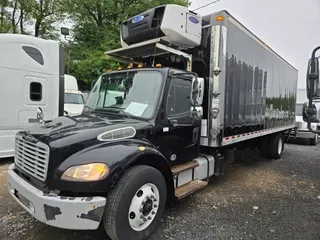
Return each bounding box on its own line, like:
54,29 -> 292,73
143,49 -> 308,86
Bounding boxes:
190,0 -> 320,88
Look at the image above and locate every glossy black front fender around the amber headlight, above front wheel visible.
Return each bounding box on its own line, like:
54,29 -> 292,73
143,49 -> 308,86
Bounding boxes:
49,139 -> 171,193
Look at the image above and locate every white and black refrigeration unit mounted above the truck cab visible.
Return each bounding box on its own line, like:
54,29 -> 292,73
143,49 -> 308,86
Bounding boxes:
121,4 -> 202,49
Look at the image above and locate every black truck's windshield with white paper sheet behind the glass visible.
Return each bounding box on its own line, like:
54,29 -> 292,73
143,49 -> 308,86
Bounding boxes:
85,70 -> 163,118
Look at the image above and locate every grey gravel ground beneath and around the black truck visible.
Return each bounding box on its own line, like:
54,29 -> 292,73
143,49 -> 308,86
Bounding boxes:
0,142 -> 320,240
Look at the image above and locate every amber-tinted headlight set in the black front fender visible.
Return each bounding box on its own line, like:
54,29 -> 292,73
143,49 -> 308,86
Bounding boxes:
61,163 -> 109,182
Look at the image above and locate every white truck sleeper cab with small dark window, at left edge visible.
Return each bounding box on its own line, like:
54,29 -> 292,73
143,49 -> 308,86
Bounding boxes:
0,34 -> 64,158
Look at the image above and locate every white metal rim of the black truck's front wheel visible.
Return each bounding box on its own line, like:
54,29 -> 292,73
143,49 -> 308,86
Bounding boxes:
128,183 -> 160,232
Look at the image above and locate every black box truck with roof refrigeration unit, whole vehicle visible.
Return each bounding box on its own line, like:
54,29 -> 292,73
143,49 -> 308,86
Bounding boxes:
7,5 -> 297,240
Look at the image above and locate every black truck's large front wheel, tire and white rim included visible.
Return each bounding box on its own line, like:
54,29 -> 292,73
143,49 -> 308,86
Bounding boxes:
103,165 -> 167,240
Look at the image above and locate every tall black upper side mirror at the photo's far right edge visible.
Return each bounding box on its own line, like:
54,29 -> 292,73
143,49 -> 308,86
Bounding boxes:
307,53 -> 320,100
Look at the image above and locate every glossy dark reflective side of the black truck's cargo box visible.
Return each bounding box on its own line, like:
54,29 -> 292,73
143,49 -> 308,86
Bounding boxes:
206,11 -> 298,145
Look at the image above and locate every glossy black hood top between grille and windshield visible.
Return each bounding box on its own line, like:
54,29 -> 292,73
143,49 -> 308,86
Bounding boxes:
22,113 -> 152,149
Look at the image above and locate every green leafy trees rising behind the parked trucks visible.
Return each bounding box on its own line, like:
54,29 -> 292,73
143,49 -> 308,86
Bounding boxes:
0,0 -> 190,89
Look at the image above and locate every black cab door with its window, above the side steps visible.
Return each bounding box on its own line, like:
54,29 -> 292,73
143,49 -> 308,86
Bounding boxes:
160,75 -> 201,164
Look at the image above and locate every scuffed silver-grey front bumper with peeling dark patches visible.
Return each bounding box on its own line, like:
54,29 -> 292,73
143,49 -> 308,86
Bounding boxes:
7,164 -> 106,230
